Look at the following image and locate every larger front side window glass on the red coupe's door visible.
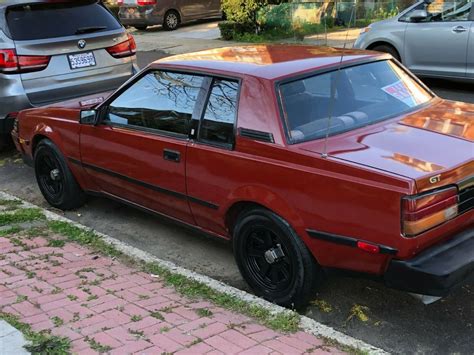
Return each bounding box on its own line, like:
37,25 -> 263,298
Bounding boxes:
103,71 -> 203,136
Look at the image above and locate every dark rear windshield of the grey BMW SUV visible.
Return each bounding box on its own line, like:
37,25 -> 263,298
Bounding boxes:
6,1 -> 121,41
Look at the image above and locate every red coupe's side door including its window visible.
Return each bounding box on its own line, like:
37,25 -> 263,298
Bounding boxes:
81,70 -> 204,223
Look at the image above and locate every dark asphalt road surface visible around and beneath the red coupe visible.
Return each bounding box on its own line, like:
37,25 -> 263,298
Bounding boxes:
0,52 -> 474,354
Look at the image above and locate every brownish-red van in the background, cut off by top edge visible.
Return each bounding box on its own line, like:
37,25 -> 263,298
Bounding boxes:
117,0 -> 223,31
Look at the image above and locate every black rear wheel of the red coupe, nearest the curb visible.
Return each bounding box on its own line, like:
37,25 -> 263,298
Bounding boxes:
233,208 -> 324,309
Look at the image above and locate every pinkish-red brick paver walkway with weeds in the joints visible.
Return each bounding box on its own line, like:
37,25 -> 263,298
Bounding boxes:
0,231 -> 340,355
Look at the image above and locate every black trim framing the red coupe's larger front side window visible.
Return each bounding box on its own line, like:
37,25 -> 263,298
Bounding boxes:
95,68 -> 206,141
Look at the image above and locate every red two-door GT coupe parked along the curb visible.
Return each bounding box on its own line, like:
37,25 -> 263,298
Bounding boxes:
13,45 -> 474,307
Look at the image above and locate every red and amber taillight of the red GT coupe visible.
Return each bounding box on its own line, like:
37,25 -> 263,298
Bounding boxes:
402,187 -> 459,237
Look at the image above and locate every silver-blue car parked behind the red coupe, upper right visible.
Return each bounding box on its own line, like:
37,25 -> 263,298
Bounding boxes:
354,0 -> 474,80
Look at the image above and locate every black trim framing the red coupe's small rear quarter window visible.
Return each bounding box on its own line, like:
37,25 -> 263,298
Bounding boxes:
193,76 -> 242,150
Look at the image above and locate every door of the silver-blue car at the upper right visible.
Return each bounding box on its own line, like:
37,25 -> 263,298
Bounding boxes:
403,0 -> 472,77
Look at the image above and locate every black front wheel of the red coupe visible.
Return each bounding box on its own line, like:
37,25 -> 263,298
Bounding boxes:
34,139 -> 86,210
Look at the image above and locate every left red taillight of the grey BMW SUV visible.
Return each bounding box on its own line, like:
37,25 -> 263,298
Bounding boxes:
0,49 -> 51,74
